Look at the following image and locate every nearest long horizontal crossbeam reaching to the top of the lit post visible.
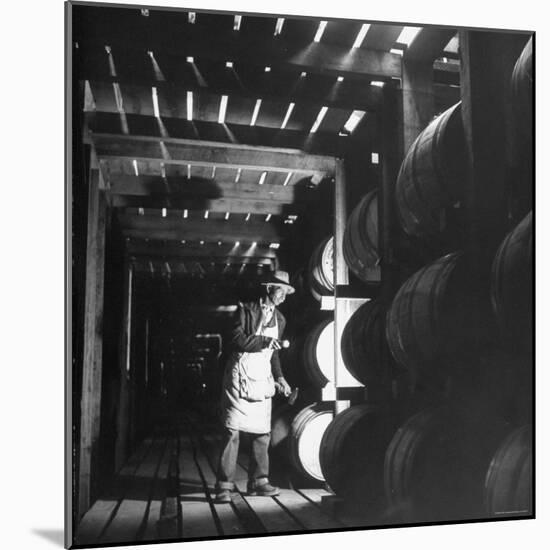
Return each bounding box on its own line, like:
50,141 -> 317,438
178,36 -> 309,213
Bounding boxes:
92,134 -> 334,179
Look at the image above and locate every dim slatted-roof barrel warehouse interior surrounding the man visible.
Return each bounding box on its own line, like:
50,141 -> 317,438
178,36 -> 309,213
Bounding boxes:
66,2 -> 534,546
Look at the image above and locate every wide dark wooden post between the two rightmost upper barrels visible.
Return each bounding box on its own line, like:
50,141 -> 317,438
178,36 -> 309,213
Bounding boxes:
459,31 -> 528,265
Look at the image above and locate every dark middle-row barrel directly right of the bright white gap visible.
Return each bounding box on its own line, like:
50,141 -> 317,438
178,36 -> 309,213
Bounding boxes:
341,300 -> 390,385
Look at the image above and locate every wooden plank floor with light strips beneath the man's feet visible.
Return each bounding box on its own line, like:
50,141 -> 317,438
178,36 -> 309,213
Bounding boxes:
75,423 -> 345,546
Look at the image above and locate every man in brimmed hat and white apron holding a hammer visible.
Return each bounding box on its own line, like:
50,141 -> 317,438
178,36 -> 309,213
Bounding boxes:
216,271 -> 294,502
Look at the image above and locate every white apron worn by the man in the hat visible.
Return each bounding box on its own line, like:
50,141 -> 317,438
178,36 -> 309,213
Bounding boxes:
222,317 -> 279,434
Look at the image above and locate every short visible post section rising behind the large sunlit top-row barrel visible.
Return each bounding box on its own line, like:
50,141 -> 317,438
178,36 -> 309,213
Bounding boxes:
403,59 -> 435,152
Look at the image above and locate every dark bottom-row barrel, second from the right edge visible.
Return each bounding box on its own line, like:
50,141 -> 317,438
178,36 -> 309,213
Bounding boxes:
384,404 -> 508,522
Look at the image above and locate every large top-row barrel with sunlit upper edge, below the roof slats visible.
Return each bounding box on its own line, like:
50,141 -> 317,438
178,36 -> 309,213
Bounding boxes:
395,103 -> 468,238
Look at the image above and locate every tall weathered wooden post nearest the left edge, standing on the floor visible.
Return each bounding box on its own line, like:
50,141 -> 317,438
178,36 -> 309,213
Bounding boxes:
78,169 -> 107,518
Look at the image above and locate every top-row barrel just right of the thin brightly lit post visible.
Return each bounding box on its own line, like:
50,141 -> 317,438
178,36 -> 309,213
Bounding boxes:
343,190 -> 380,282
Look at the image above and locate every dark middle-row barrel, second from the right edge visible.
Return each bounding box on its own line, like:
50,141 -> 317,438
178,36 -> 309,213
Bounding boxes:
386,252 -> 490,380
